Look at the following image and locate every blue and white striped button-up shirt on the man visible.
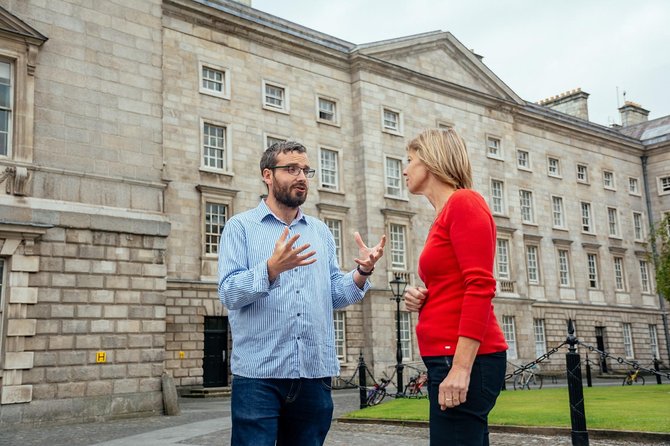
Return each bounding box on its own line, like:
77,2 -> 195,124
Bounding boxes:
219,201 -> 370,378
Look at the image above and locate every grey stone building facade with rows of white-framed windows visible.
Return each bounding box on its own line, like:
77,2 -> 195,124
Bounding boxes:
0,0 -> 670,424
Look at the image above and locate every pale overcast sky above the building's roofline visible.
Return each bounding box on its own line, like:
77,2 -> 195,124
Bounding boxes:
252,0 -> 670,125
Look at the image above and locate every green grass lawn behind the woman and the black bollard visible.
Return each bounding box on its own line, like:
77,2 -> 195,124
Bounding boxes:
346,384 -> 670,432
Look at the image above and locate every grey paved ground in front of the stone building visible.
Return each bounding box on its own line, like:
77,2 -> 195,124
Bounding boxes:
0,390 -> 658,446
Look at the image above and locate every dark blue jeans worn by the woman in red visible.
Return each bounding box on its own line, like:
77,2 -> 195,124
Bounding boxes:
422,352 -> 507,446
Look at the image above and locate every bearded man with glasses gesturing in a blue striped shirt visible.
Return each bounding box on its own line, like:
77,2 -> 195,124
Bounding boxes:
219,141 -> 386,446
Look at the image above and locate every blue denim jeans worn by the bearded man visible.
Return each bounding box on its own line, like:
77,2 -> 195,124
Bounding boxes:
231,375 -> 333,446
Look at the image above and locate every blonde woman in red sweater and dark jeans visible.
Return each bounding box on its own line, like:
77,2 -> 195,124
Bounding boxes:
403,129 -> 507,446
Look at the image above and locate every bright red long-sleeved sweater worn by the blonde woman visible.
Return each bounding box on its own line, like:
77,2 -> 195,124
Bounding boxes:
416,189 -> 507,356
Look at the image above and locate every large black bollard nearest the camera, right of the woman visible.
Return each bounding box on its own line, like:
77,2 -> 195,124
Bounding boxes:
565,319 -> 589,446
